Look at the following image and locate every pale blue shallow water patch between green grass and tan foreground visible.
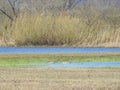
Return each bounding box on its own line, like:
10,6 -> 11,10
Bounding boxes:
28,62 -> 120,68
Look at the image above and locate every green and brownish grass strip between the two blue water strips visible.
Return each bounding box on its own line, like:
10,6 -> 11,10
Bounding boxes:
0,54 -> 120,67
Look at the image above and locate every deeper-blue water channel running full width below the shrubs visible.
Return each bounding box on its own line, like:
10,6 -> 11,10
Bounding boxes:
0,47 -> 120,54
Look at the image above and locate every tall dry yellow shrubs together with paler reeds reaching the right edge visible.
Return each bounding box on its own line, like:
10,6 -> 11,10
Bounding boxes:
0,14 -> 120,47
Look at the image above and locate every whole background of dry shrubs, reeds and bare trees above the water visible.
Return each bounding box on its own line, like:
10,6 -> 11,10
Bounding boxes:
0,0 -> 120,47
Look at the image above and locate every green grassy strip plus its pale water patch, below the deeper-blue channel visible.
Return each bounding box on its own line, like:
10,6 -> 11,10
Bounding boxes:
0,54 -> 120,69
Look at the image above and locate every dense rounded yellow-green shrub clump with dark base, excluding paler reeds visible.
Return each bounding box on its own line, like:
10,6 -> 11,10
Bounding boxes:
11,15 -> 80,45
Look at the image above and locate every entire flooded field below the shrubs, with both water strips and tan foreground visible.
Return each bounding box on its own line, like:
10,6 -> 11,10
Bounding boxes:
0,48 -> 120,90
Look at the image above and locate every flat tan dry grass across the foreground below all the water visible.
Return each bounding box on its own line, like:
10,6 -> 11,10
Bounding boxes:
0,69 -> 120,90
